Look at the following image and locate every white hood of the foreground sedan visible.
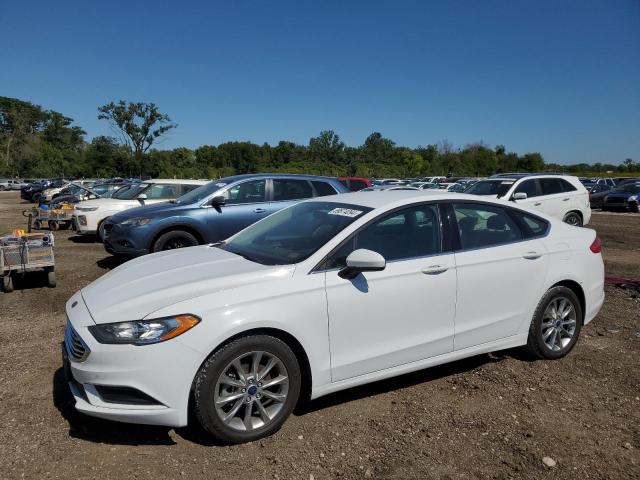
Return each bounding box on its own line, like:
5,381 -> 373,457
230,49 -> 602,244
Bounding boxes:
82,245 -> 295,324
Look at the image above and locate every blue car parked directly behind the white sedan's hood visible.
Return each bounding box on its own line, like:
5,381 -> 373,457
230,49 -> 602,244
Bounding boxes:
103,174 -> 348,256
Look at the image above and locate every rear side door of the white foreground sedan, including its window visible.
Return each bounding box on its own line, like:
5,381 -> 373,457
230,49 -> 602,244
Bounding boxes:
453,202 -> 548,350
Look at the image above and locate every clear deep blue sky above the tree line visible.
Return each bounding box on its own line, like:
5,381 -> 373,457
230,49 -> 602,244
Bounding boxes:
0,0 -> 640,163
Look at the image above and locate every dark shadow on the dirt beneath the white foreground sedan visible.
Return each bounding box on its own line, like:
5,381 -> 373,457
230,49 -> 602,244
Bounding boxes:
53,350 -> 513,446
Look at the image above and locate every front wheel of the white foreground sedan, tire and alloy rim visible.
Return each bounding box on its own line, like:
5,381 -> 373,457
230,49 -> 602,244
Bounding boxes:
193,335 -> 302,444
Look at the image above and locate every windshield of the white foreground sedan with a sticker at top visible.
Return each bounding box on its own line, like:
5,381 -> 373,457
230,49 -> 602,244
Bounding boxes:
220,202 -> 371,265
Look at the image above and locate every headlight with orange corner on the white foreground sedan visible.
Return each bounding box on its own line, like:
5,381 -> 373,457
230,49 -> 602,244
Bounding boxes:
89,315 -> 200,345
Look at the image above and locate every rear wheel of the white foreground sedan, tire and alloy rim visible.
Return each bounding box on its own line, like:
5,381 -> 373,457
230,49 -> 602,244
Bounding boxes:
526,286 -> 583,360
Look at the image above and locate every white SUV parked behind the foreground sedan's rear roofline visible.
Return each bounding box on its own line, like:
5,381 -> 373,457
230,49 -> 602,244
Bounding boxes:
464,174 -> 591,227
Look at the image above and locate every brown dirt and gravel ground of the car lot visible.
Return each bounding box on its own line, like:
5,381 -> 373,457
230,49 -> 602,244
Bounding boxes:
0,192 -> 640,480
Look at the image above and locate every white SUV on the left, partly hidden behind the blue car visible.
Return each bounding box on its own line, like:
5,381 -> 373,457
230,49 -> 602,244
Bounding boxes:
73,179 -> 208,239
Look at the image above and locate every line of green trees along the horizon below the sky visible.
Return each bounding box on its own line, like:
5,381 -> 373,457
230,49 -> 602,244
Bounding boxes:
0,97 -> 640,178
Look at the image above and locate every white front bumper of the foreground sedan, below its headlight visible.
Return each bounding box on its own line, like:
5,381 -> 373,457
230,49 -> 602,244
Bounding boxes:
63,293 -> 204,427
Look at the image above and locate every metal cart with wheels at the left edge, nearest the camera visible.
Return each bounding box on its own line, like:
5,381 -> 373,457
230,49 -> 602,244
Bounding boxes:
0,233 -> 56,293
